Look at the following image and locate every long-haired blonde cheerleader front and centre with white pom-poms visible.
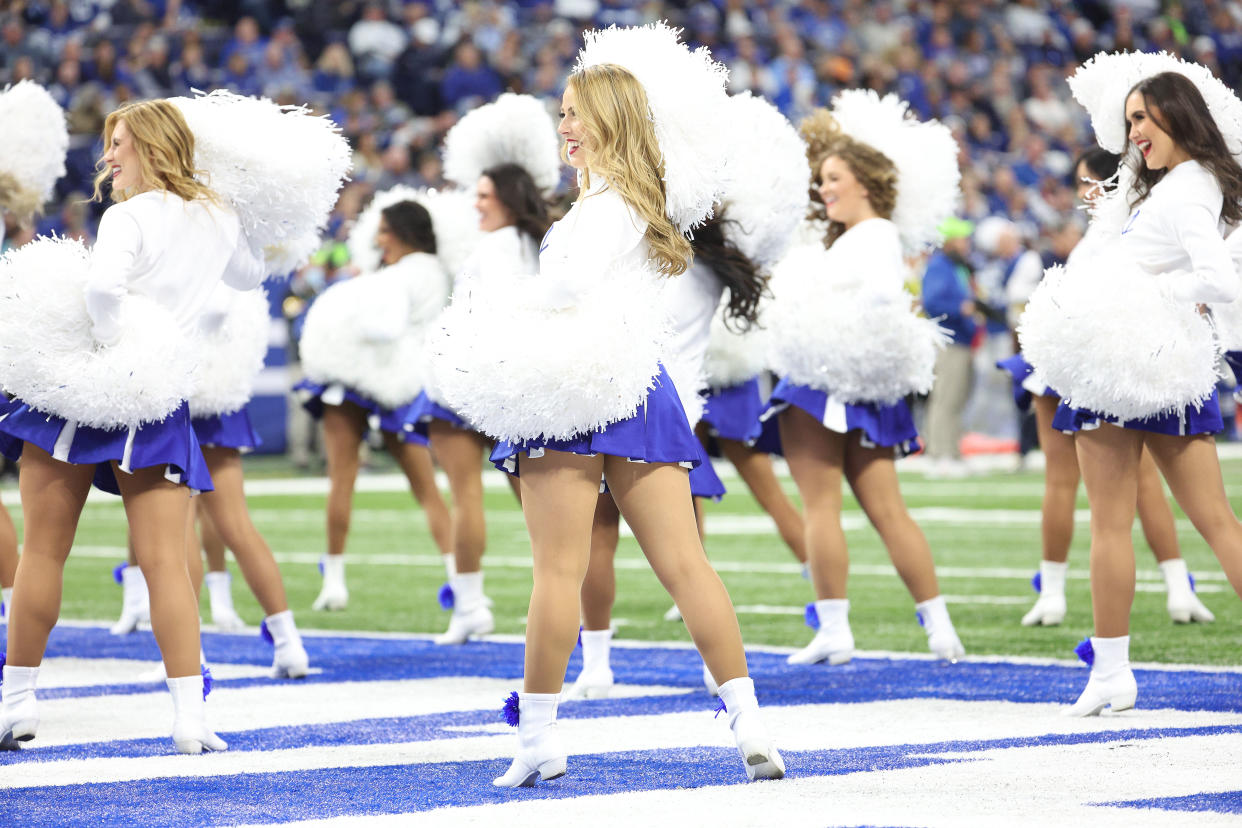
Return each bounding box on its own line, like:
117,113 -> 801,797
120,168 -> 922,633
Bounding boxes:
433,25 -> 784,787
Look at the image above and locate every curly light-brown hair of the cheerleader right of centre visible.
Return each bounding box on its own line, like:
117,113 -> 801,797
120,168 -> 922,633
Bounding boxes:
797,109 -> 897,247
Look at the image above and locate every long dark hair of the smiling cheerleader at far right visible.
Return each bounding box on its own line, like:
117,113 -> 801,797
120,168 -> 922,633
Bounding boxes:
1125,72 -> 1242,223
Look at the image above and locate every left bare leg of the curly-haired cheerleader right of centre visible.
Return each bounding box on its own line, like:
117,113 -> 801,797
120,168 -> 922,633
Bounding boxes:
780,407 -> 850,600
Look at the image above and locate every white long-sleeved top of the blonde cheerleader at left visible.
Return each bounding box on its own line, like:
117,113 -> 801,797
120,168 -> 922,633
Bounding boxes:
86,191 -> 265,345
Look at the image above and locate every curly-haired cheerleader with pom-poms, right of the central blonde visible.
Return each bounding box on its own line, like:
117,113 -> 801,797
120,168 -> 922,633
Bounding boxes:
756,91 -> 965,664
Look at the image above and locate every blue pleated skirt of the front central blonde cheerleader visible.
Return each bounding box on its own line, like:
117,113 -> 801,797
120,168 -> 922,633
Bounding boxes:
492,365 -> 723,476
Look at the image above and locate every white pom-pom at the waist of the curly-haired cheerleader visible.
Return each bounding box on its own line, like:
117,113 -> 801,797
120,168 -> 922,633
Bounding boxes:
765,243 -> 948,403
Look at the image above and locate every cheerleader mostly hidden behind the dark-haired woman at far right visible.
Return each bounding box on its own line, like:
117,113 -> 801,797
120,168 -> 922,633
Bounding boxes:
996,146 -> 1215,627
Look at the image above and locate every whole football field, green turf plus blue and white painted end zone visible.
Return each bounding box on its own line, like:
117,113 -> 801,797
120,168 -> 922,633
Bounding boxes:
0,451 -> 1242,826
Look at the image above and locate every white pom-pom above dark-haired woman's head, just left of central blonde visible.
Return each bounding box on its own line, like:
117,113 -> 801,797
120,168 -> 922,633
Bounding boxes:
445,92 -> 560,195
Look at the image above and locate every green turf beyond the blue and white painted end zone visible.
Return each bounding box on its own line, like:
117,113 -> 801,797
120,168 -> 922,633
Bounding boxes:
4,454 -> 1242,664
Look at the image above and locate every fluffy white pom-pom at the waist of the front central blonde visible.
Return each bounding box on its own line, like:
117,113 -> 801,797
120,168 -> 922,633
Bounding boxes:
427,271 -> 668,442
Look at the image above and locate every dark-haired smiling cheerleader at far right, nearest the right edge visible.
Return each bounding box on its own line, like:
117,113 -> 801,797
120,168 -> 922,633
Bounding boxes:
1020,55 -> 1242,716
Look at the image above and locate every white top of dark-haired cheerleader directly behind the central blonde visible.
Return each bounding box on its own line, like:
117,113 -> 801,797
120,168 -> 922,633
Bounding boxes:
661,261 -> 724,428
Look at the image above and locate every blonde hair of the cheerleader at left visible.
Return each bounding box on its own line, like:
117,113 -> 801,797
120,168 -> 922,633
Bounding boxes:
93,98 -> 219,204
